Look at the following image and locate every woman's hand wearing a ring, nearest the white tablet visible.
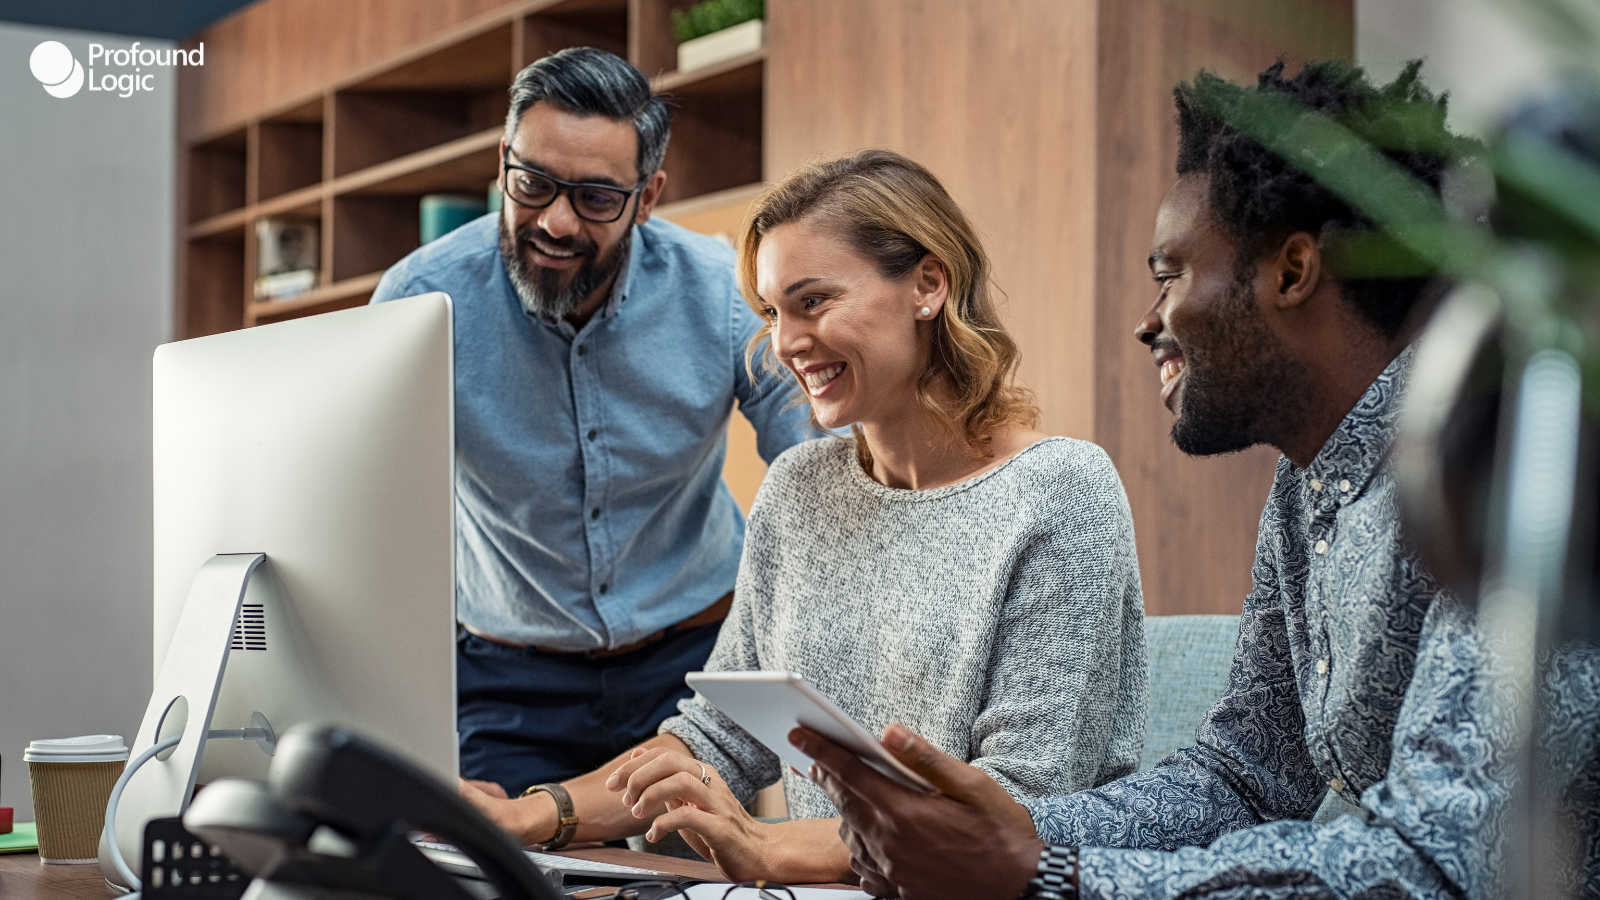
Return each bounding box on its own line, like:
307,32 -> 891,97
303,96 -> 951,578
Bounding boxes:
605,748 -> 774,881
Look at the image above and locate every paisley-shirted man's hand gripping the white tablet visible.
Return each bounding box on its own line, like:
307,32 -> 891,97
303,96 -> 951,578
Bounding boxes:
789,724 -> 1045,900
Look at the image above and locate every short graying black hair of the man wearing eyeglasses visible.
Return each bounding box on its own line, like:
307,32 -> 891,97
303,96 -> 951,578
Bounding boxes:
506,46 -> 672,178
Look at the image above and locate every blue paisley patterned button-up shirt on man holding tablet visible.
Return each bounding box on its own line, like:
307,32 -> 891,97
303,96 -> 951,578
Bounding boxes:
1027,351 -> 1600,898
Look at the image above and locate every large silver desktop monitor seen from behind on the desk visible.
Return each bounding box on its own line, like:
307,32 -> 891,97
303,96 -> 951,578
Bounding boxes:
102,293 -> 458,873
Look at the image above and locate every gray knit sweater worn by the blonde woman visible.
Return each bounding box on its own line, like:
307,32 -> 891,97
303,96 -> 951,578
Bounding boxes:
661,437 -> 1147,818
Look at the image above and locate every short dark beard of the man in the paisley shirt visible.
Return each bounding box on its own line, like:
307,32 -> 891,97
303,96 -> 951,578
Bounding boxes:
1173,264 -> 1310,456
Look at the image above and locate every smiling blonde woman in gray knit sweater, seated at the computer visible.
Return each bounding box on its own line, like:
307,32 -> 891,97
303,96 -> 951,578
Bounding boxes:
462,151 -> 1146,884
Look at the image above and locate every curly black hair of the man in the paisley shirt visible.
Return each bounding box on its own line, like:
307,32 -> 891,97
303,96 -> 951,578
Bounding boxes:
1173,59 -> 1469,338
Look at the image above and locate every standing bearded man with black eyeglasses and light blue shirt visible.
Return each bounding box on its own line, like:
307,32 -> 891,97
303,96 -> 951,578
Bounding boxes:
373,48 -> 808,826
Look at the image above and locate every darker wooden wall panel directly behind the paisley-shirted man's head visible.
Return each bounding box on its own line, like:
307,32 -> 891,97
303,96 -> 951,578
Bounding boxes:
1094,0 -> 1354,613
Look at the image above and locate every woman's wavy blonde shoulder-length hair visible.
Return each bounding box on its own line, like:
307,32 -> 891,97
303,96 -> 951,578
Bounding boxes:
739,151 -> 1038,464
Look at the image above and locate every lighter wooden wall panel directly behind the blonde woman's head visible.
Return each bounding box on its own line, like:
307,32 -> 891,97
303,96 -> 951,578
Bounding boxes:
765,0 -> 1094,437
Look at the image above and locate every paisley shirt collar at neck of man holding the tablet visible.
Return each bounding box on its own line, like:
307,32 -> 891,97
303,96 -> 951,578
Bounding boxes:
1306,344 -> 1416,503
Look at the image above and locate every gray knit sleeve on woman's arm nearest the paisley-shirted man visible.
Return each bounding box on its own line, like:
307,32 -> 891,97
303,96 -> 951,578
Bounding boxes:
971,444 -> 1147,798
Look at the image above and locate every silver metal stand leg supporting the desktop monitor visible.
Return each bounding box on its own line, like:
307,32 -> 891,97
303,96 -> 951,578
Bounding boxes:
99,552 -> 272,887
